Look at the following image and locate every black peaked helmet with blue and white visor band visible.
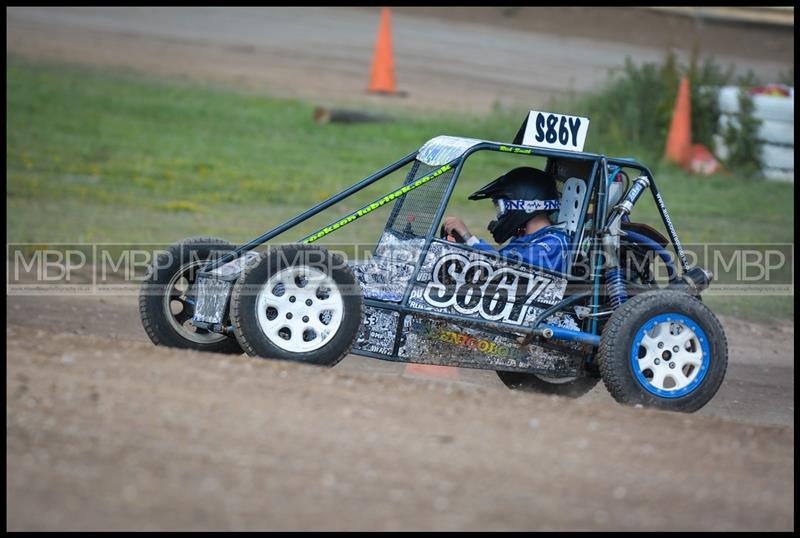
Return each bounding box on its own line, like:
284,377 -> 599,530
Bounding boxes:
469,166 -> 561,244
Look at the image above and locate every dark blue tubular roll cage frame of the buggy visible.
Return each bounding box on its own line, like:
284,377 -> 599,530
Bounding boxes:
203,141 -> 689,347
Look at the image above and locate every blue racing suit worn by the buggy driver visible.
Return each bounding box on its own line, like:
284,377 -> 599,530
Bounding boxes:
470,226 -> 569,273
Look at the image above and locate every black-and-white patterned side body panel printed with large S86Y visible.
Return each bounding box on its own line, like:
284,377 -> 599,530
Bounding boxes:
352,237 -> 584,377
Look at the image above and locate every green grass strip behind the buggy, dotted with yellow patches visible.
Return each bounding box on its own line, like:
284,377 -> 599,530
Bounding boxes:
6,56 -> 794,318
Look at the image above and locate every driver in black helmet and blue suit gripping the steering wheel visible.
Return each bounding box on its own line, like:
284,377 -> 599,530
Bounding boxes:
443,167 -> 569,273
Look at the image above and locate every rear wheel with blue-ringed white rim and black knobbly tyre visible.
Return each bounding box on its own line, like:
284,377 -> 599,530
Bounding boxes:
598,290 -> 728,413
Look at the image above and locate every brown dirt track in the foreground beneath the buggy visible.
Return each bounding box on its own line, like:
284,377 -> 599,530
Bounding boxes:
6,297 -> 794,530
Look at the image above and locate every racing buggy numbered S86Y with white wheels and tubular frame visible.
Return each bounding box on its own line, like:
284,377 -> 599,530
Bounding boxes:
139,111 -> 728,412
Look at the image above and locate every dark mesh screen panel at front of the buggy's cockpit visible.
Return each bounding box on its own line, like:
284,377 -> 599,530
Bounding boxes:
387,161 -> 455,237
